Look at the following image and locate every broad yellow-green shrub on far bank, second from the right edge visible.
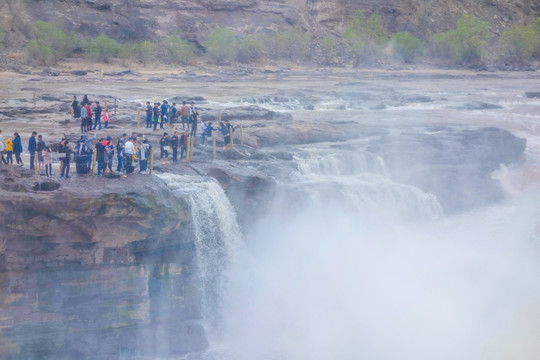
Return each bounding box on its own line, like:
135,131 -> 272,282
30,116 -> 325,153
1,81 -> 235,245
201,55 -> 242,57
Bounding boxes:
431,15 -> 492,64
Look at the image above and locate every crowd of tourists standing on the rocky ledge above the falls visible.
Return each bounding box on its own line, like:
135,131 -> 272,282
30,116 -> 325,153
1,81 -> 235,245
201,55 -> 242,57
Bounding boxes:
0,95 -> 234,179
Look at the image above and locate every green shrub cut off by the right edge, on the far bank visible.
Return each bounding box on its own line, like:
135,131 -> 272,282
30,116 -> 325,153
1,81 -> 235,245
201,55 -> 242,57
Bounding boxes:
499,24 -> 539,62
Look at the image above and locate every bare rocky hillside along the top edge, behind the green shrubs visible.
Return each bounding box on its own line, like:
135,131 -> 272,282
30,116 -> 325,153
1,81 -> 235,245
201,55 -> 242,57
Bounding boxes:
0,0 -> 540,47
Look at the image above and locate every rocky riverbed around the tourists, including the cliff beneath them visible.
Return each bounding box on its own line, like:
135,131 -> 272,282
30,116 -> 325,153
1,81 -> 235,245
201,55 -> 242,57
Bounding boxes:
0,68 -> 538,359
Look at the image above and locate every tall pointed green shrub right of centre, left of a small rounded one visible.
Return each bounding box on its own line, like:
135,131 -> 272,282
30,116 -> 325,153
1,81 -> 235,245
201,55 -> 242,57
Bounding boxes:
344,10 -> 388,66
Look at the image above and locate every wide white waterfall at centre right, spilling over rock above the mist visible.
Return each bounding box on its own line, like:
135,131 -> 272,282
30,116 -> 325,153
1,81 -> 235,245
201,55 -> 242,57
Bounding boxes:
290,150 -> 443,220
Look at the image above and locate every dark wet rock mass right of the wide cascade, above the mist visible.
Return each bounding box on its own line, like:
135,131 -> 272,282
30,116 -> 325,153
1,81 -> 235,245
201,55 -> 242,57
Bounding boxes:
368,128 -> 526,213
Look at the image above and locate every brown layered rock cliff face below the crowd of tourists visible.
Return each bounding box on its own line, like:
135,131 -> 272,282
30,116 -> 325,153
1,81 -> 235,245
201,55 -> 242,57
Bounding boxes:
0,168 -> 207,359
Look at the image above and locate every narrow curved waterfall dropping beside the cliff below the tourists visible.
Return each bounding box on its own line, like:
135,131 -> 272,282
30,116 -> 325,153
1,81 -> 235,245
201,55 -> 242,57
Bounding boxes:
157,173 -> 242,325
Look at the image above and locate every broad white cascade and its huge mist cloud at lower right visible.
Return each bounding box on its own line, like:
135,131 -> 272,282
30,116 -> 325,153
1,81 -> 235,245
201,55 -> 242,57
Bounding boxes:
209,145 -> 540,360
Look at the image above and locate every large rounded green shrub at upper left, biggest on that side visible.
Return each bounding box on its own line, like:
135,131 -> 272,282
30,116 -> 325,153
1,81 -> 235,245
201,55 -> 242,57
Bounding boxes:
26,20 -> 78,64
